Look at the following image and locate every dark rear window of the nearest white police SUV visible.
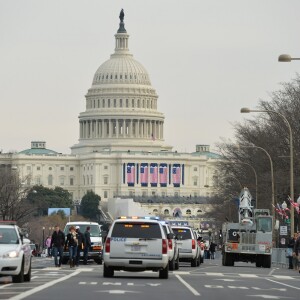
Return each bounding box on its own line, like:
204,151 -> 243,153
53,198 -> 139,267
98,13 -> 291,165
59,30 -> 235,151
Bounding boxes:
111,222 -> 162,239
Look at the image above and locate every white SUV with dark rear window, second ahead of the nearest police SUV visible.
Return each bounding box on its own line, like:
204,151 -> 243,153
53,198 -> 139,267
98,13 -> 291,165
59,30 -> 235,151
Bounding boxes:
172,226 -> 200,267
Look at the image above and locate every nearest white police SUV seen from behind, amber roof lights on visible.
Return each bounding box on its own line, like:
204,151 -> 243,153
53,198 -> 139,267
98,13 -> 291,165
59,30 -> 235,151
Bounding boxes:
103,217 -> 171,279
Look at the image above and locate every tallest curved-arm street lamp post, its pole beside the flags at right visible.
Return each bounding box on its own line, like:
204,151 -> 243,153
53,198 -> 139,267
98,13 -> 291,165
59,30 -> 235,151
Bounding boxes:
241,107 -> 294,236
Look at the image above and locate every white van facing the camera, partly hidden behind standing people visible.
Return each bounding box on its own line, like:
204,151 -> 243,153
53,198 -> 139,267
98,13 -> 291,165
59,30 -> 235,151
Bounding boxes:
62,221 -> 103,265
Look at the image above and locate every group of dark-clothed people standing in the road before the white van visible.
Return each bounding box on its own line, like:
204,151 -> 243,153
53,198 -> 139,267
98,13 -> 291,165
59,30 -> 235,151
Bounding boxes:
47,225 -> 91,268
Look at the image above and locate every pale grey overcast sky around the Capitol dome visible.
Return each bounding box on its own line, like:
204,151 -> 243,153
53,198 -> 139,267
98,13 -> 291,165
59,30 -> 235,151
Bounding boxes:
0,0 -> 300,153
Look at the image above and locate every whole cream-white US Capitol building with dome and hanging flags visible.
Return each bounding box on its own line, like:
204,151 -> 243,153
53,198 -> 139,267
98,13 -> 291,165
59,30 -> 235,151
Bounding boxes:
0,10 -> 219,223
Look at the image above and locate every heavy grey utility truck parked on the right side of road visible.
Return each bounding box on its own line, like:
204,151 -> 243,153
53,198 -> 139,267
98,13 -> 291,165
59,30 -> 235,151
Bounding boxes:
222,188 -> 273,268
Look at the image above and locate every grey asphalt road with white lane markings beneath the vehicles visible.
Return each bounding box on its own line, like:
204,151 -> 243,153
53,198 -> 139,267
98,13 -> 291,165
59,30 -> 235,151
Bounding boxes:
0,258 -> 300,300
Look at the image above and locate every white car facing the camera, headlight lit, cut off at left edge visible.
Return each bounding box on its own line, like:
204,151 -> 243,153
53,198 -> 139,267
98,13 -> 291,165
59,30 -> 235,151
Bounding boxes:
0,221 -> 31,282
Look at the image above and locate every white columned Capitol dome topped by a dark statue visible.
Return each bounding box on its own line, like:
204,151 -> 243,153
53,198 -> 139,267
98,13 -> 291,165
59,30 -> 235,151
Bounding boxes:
71,11 -> 171,154
